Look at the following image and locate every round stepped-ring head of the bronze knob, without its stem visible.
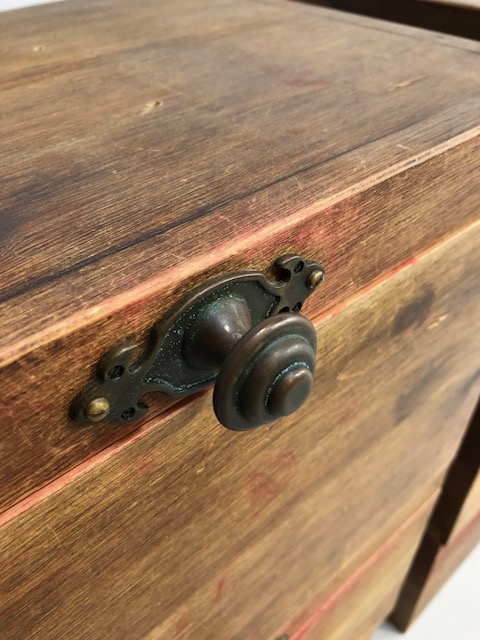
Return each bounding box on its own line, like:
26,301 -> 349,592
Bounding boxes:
213,314 -> 317,431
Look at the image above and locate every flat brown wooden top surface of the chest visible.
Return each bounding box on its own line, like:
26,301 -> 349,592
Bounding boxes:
0,0 -> 480,361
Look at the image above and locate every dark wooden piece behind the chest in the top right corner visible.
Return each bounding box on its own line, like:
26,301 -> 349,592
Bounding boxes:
302,0 -> 480,40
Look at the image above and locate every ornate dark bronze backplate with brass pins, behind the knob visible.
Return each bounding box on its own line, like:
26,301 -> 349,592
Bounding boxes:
71,254 -> 324,424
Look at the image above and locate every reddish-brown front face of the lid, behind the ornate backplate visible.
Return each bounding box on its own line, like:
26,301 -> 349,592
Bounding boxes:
0,139 -> 480,508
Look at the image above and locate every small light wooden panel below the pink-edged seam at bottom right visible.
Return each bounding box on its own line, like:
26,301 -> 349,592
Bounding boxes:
285,494 -> 438,640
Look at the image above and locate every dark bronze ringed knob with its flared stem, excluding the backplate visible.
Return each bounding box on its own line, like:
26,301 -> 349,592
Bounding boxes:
184,296 -> 317,431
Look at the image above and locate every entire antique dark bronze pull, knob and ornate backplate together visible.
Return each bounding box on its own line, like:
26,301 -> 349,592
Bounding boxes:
72,254 -> 325,431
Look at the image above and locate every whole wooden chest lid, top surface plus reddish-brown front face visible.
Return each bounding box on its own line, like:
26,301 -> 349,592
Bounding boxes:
0,0 -> 480,508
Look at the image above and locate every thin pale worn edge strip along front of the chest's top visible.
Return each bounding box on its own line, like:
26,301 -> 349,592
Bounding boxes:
0,126 -> 480,368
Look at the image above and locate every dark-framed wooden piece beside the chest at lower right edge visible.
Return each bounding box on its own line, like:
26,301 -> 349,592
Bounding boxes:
392,398 -> 480,630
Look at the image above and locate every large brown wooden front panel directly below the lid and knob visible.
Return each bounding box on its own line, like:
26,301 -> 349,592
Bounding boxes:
0,224 -> 480,640
